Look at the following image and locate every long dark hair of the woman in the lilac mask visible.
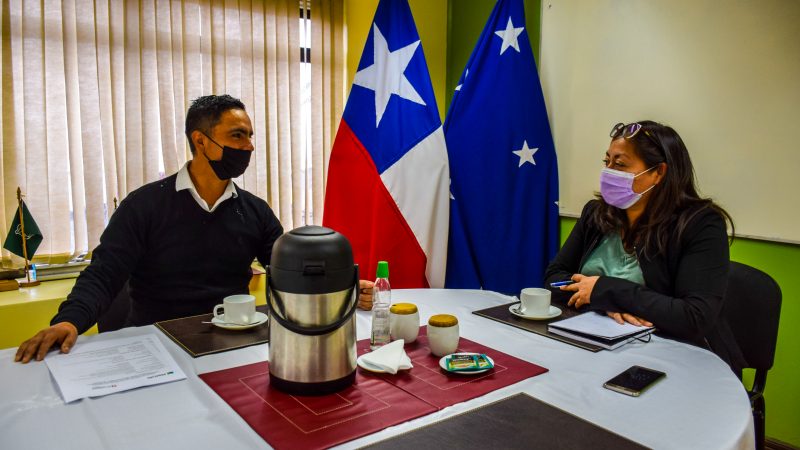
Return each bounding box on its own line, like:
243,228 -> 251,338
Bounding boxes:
590,120 -> 734,258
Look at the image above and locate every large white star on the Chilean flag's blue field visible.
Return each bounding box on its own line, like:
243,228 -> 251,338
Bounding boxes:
353,24 -> 426,128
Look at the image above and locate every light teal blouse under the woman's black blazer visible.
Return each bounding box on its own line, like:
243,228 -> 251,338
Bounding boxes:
580,233 -> 644,286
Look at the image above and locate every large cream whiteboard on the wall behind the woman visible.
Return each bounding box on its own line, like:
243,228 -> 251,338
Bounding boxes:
540,0 -> 800,242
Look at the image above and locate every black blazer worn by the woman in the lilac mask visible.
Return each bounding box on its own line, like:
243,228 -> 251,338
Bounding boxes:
545,201 -> 744,373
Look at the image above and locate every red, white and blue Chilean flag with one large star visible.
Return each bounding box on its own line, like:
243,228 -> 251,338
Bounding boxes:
322,0 -> 450,288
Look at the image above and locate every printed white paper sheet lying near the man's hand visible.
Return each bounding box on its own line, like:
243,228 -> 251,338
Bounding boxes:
45,334 -> 186,403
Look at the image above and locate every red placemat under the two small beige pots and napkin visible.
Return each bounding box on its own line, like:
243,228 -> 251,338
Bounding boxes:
357,327 -> 547,409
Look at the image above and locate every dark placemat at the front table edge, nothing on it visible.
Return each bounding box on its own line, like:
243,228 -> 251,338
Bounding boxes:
367,393 -> 647,450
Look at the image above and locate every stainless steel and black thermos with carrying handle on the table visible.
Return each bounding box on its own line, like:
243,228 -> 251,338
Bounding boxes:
267,226 -> 358,395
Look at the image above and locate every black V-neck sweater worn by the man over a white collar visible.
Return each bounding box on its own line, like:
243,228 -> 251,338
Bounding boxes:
51,175 -> 283,333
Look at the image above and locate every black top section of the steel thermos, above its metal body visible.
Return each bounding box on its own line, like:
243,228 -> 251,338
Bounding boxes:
269,225 -> 356,294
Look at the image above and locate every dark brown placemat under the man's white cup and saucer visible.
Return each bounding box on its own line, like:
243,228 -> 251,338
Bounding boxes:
155,305 -> 269,358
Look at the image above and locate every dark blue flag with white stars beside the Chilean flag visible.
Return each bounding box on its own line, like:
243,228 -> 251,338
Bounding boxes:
444,0 -> 558,295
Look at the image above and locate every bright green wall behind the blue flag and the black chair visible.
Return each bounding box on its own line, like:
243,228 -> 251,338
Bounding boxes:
446,0 -> 800,446
